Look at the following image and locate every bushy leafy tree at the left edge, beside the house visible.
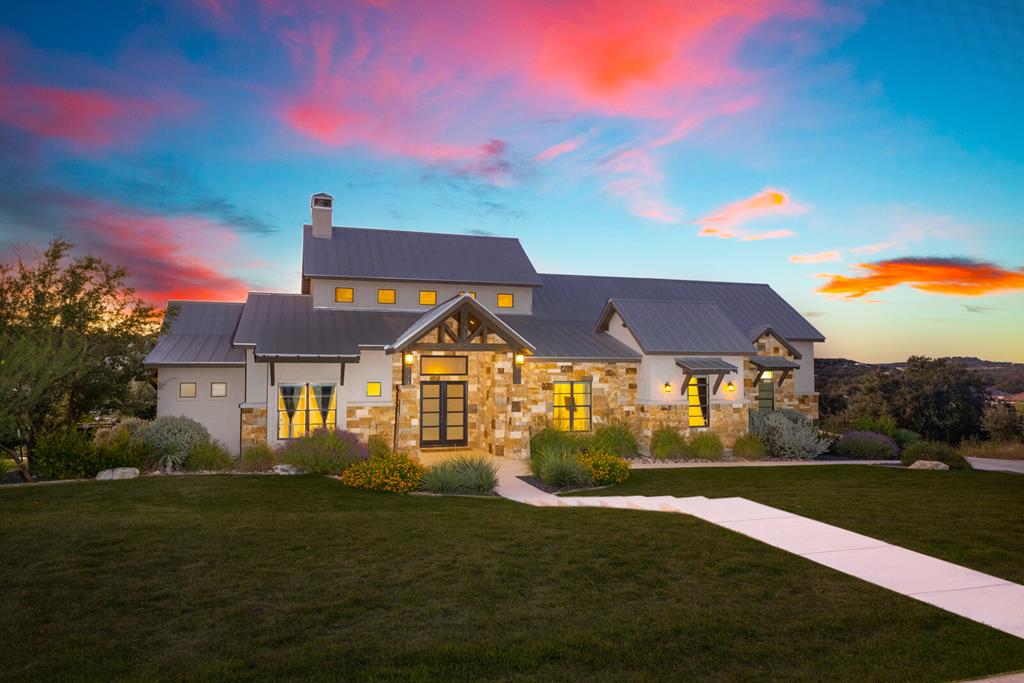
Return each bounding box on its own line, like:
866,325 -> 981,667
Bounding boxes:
0,238 -> 160,475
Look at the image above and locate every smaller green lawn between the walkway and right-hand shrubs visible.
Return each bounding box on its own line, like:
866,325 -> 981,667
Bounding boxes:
592,465 -> 1024,583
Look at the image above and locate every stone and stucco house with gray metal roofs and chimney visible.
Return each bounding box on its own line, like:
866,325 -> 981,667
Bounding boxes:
146,194 -> 824,458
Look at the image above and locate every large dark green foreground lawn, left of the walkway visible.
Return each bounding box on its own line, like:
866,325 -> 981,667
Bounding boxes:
0,479 -> 1024,681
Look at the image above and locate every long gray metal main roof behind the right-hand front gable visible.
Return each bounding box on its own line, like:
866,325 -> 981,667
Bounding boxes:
534,273 -> 824,342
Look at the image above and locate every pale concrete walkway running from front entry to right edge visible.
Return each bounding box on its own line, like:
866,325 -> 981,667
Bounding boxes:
497,459 -> 1024,638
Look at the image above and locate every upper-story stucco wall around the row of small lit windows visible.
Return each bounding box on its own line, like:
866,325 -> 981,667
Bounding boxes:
310,279 -> 534,315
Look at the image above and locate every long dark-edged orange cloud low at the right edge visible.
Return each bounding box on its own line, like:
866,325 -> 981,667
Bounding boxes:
818,256 -> 1024,299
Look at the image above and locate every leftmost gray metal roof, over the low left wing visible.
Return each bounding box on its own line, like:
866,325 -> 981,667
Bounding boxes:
145,301 -> 246,367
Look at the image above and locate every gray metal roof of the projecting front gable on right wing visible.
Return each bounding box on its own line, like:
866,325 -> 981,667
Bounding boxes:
597,299 -> 755,354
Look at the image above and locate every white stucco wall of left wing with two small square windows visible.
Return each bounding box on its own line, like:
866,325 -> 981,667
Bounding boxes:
157,367 -> 245,456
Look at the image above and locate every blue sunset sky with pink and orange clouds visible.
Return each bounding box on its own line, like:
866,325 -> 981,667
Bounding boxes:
0,0 -> 1024,361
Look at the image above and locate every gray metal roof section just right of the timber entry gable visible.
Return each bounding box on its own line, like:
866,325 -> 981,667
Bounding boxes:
502,315 -> 640,362
